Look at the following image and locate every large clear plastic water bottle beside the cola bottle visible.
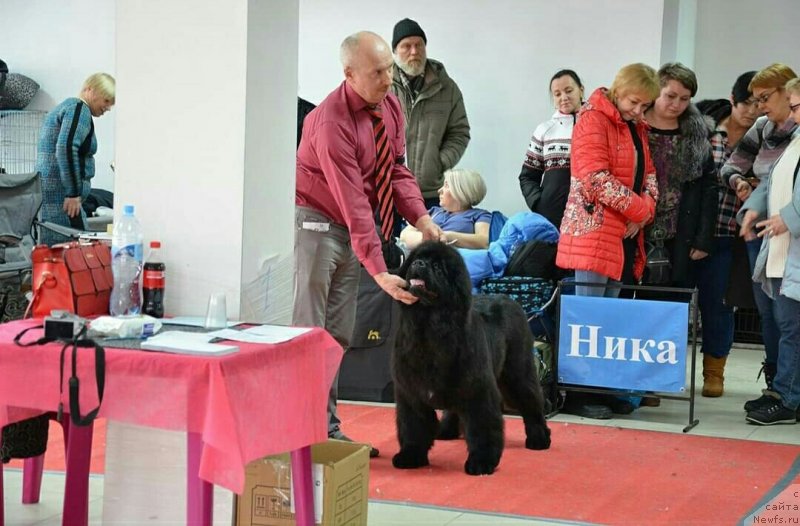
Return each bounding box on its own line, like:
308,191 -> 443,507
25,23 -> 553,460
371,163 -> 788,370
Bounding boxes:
108,205 -> 143,316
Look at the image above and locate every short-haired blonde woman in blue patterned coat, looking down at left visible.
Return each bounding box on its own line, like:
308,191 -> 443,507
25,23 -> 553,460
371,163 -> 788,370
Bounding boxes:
36,73 -> 116,245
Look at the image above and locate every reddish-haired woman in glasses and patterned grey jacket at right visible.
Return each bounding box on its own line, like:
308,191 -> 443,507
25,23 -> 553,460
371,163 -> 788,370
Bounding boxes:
720,64 -> 797,411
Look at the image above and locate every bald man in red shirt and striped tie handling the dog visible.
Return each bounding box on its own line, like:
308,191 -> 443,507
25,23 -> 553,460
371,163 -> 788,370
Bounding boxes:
292,31 -> 444,456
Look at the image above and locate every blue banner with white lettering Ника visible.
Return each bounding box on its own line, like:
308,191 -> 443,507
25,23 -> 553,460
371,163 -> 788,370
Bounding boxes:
558,296 -> 689,392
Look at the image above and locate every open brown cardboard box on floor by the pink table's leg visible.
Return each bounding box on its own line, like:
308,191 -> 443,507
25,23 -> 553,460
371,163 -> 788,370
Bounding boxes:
233,440 -> 369,526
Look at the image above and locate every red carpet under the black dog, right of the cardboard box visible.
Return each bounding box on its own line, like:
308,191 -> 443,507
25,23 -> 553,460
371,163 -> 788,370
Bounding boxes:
340,404 -> 800,525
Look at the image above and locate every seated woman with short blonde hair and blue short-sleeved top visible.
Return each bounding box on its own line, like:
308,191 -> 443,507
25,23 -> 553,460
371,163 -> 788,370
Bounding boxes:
400,169 -> 492,249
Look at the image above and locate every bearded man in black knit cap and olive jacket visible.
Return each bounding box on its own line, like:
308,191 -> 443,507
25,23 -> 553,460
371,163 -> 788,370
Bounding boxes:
392,18 -> 469,209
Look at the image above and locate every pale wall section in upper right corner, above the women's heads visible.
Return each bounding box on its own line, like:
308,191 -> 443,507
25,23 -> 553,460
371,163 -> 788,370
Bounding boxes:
695,0 -> 800,100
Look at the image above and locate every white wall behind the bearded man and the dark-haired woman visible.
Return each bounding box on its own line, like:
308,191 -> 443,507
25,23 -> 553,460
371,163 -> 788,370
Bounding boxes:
299,0 -> 663,214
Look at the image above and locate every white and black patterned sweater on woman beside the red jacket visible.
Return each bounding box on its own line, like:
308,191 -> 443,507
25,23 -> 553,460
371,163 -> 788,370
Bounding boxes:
519,111 -> 576,228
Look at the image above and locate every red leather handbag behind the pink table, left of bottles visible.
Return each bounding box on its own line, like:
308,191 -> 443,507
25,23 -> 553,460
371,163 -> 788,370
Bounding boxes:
28,241 -> 114,318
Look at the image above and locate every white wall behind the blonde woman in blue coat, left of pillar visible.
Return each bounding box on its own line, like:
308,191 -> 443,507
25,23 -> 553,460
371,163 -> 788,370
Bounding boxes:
0,0 -> 116,190
